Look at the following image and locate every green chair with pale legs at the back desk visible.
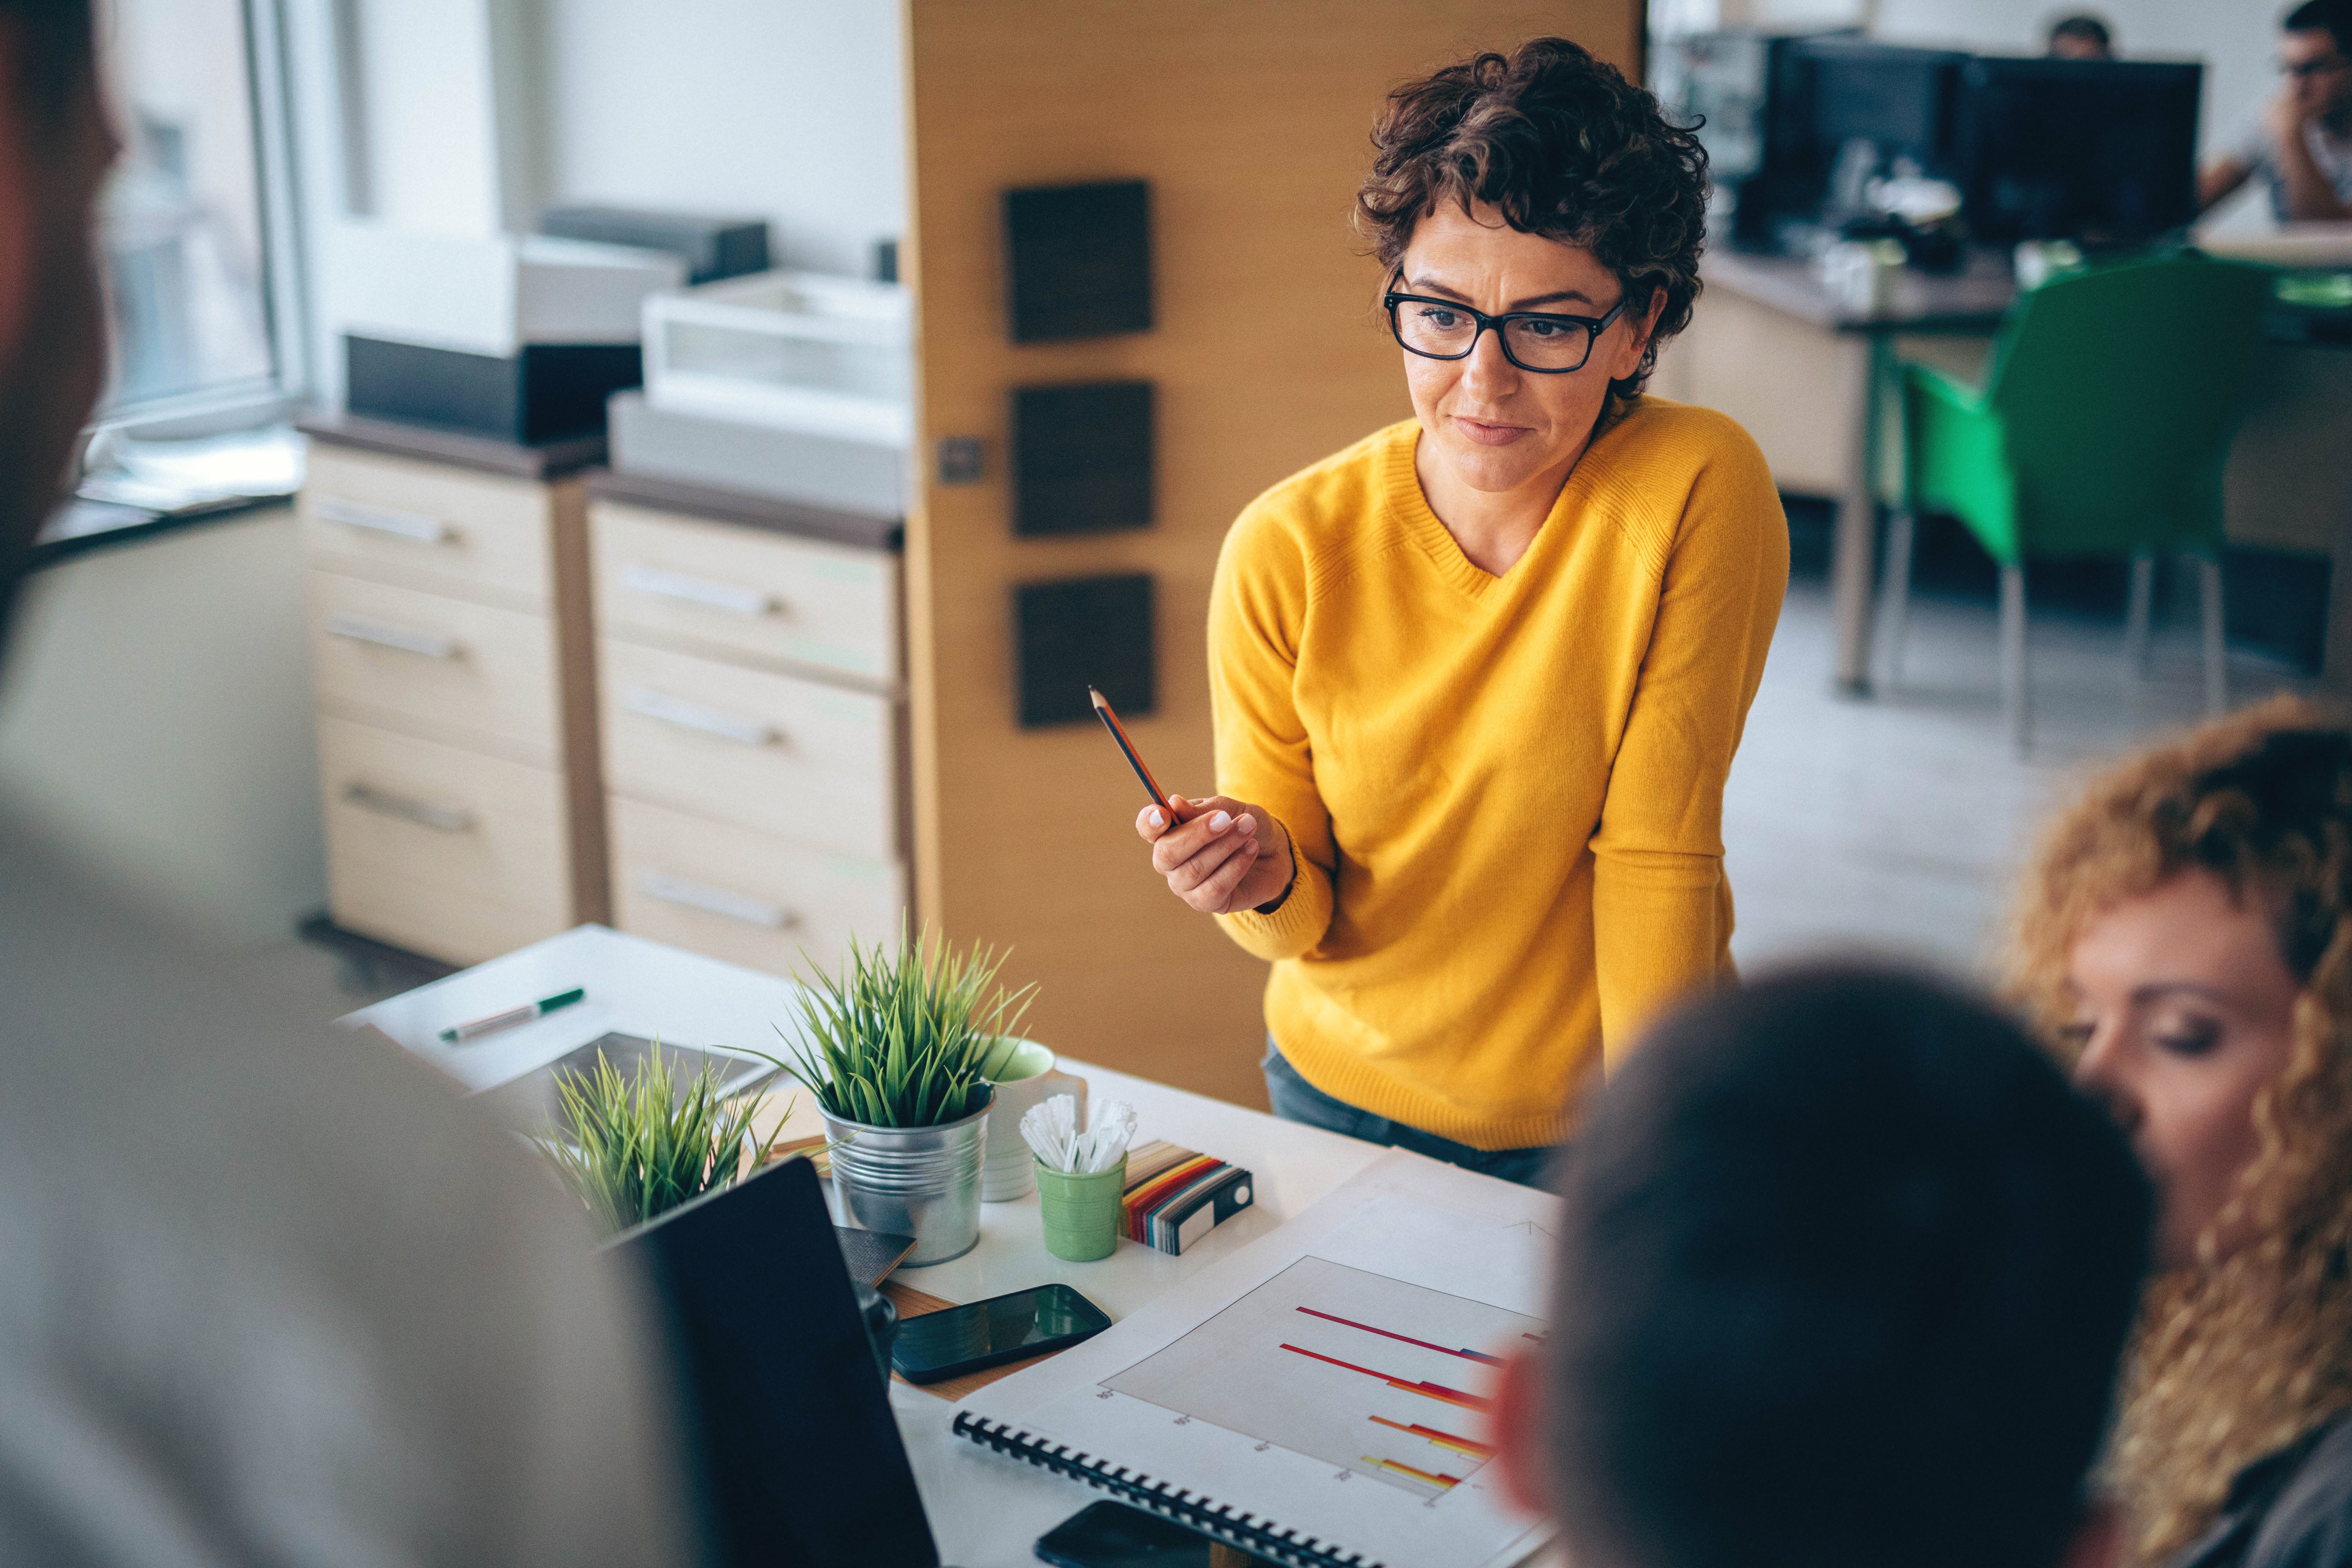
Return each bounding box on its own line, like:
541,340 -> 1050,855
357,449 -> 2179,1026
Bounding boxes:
1882,254 -> 2274,755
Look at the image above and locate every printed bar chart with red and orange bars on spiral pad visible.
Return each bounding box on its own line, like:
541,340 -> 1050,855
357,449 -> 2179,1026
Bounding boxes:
1101,1258 -> 1543,1500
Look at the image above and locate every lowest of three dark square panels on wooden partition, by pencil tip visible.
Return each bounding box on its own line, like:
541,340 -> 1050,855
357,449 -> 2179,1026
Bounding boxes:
1014,574 -> 1157,729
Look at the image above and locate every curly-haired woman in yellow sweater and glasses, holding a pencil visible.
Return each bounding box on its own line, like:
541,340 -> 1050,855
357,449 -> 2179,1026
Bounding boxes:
1136,37 -> 1787,1180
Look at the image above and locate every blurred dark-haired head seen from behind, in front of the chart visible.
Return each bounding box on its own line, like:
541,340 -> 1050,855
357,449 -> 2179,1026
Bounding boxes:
1491,966 -> 2152,1568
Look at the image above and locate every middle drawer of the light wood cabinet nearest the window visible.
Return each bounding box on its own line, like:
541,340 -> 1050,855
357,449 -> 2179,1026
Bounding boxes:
310,571 -> 560,766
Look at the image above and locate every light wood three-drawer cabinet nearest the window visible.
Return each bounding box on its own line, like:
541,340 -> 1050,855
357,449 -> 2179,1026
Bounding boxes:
301,419 -> 611,964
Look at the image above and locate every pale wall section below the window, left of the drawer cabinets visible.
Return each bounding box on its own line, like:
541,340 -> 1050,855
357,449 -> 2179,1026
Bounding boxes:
0,508 -> 327,947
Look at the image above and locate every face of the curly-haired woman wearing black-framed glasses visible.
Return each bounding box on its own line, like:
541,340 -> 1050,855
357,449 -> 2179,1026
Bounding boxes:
1395,204 -> 1663,491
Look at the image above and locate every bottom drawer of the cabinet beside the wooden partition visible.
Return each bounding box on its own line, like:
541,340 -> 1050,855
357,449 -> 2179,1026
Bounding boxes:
609,794 -> 905,975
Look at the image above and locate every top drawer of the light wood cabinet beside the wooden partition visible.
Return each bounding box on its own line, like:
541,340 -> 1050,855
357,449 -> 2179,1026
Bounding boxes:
588,501 -> 898,686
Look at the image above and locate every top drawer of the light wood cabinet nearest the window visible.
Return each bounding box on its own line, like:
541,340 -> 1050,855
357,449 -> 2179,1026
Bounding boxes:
299,442 -> 555,609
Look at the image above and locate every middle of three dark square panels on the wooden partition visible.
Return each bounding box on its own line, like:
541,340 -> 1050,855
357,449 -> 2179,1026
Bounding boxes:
1011,381 -> 1153,536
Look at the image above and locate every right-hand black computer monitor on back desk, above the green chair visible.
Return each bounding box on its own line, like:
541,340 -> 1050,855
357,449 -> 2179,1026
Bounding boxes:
1959,56 -> 2204,245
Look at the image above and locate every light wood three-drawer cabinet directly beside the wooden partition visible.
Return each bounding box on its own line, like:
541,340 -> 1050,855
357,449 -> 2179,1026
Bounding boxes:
588,470 -> 910,973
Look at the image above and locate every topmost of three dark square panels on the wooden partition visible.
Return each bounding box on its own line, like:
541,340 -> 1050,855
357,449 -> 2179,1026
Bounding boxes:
1004,178 -> 1153,343
